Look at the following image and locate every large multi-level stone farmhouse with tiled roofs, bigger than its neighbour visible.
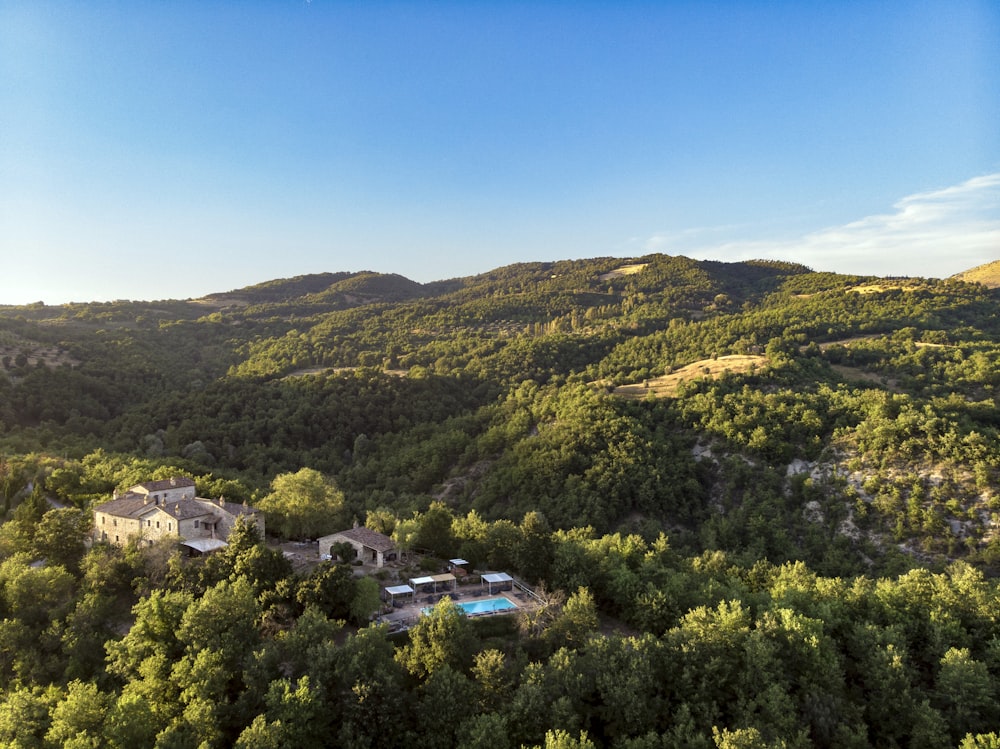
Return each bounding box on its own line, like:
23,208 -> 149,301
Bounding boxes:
94,478 -> 264,552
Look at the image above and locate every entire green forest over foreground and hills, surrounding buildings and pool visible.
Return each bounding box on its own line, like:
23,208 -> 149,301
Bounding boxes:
0,255 -> 1000,747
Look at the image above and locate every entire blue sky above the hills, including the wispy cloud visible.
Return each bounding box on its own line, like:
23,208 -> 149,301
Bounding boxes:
0,0 -> 1000,304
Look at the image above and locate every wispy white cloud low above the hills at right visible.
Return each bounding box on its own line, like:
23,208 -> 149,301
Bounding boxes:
644,173 -> 1000,278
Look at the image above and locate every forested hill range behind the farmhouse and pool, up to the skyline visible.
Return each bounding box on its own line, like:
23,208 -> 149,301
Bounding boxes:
0,255 -> 1000,571
